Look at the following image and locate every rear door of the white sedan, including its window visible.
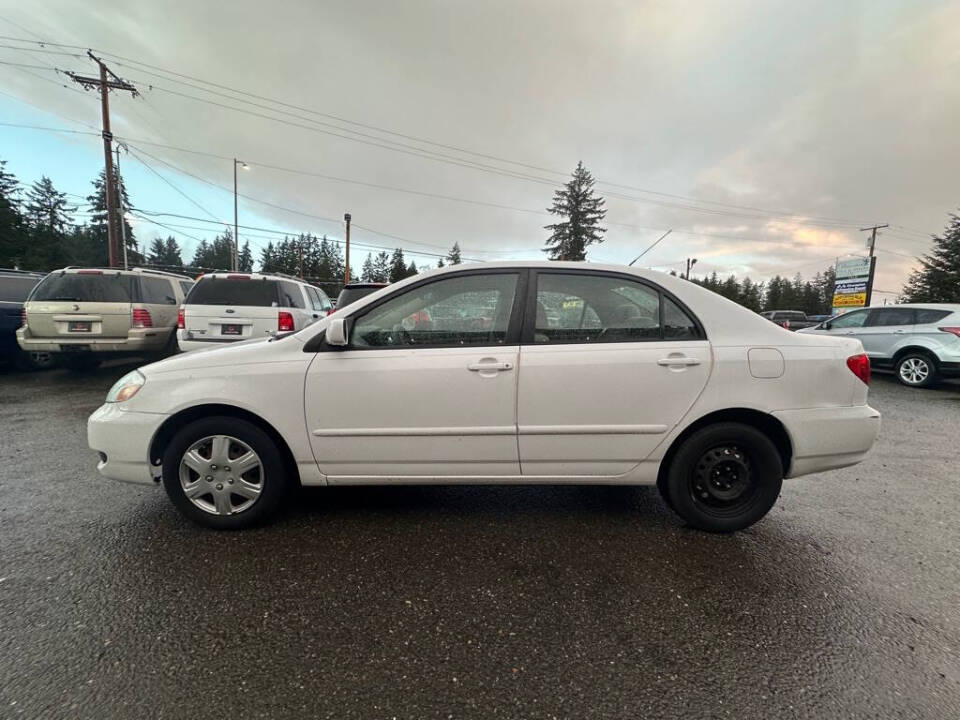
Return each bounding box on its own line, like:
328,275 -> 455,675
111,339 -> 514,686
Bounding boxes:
517,270 -> 712,477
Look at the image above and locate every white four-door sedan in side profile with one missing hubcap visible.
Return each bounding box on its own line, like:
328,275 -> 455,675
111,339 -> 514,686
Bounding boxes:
88,262 -> 880,532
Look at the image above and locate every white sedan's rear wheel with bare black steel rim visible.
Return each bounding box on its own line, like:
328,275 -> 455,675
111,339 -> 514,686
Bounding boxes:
665,422 -> 784,533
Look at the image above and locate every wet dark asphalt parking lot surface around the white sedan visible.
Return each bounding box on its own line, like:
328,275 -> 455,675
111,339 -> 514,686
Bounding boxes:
0,366 -> 960,719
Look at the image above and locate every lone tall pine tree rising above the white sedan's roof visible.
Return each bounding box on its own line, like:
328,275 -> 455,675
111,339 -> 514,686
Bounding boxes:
543,162 -> 607,261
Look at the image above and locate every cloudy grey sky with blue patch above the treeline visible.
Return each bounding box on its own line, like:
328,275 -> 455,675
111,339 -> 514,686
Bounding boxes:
0,0 -> 960,298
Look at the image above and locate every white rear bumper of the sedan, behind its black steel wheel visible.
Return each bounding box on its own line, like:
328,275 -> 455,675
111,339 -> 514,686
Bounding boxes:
773,405 -> 880,477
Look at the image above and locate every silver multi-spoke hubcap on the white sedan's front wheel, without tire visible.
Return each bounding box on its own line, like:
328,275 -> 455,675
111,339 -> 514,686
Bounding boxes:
180,435 -> 264,515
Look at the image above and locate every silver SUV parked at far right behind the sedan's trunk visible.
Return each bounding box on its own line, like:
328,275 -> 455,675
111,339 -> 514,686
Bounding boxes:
797,303 -> 960,387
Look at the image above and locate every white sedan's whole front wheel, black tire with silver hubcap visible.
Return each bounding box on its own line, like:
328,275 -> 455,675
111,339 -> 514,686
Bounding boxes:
162,416 -> 289,530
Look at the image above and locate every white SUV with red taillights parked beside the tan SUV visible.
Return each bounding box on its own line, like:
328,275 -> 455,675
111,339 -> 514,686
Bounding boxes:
177,272 -> 333,352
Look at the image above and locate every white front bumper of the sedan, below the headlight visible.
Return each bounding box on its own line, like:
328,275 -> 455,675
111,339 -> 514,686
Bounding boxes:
87,403 -> 167,485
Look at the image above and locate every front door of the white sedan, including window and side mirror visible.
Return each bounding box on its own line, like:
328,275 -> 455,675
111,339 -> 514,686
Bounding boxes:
304,270 -> 526,483
